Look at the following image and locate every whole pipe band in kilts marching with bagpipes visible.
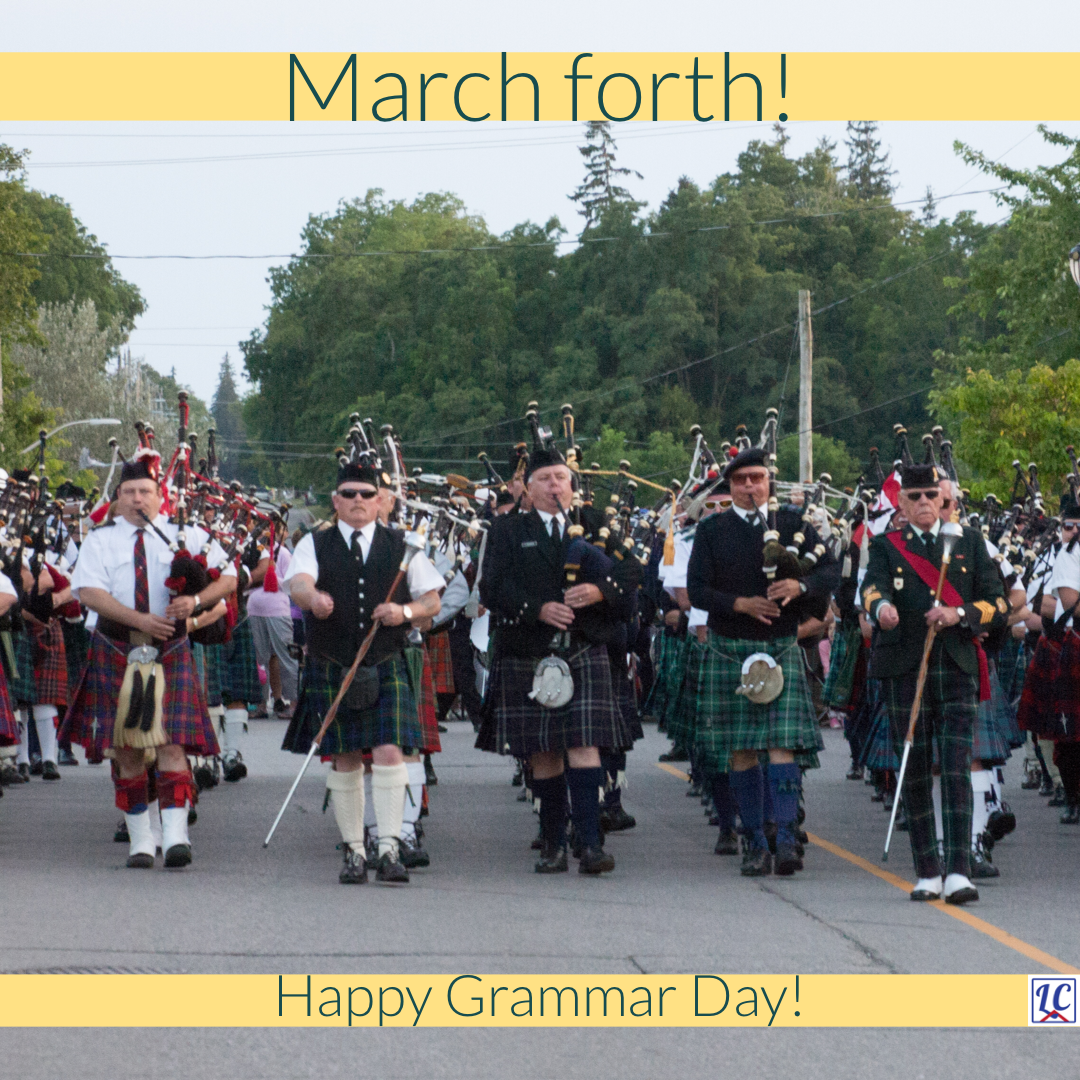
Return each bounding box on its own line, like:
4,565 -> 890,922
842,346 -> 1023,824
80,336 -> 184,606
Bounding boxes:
0,397 -> 1080,904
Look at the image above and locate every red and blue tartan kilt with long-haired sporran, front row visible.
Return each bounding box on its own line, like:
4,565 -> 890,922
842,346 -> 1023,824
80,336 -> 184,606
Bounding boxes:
60,633 -> 218,761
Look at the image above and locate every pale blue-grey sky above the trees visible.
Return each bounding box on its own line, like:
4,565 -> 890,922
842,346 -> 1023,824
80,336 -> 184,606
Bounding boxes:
0,0 -> 1080,400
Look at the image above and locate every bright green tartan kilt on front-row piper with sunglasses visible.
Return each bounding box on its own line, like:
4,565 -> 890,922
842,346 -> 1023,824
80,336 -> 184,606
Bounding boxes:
697,632 -> 821,771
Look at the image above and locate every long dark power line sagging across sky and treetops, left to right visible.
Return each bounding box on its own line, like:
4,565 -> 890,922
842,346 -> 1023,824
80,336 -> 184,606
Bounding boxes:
0,185 -> 1009,262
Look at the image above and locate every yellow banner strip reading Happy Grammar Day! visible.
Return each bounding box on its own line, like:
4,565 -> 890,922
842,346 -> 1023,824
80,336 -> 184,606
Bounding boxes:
0,974 -> 1077,1028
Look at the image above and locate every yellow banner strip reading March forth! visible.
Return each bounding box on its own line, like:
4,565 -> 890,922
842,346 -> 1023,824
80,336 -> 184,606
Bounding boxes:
0,52 -> 1078,123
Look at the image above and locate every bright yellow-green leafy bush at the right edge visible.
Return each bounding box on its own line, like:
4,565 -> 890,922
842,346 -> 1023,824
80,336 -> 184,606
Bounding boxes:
933,360 -> 1080,505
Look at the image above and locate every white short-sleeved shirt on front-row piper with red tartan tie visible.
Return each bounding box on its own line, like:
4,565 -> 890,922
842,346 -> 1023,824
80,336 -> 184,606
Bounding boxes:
71,514 -> 237,616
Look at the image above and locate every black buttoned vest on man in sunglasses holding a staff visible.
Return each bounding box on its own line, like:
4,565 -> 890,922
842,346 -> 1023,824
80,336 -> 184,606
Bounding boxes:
303,525 -> 409,667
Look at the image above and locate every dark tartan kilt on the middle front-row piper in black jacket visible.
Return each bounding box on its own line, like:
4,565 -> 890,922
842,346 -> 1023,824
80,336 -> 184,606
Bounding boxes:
476,645 -> 633,757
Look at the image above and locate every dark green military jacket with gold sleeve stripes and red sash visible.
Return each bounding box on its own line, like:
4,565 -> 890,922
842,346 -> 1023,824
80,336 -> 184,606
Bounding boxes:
861,525 -> 1009,678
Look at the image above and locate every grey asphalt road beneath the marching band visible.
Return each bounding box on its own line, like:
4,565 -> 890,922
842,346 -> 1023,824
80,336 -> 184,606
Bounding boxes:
0,721 -> 1080,1080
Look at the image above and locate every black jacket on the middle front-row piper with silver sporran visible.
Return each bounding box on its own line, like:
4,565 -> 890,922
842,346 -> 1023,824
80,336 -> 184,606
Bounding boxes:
480,510 -> 637,658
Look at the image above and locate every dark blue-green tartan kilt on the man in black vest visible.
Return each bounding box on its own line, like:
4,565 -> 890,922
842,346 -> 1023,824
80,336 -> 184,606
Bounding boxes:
281,653 -> 423,757
